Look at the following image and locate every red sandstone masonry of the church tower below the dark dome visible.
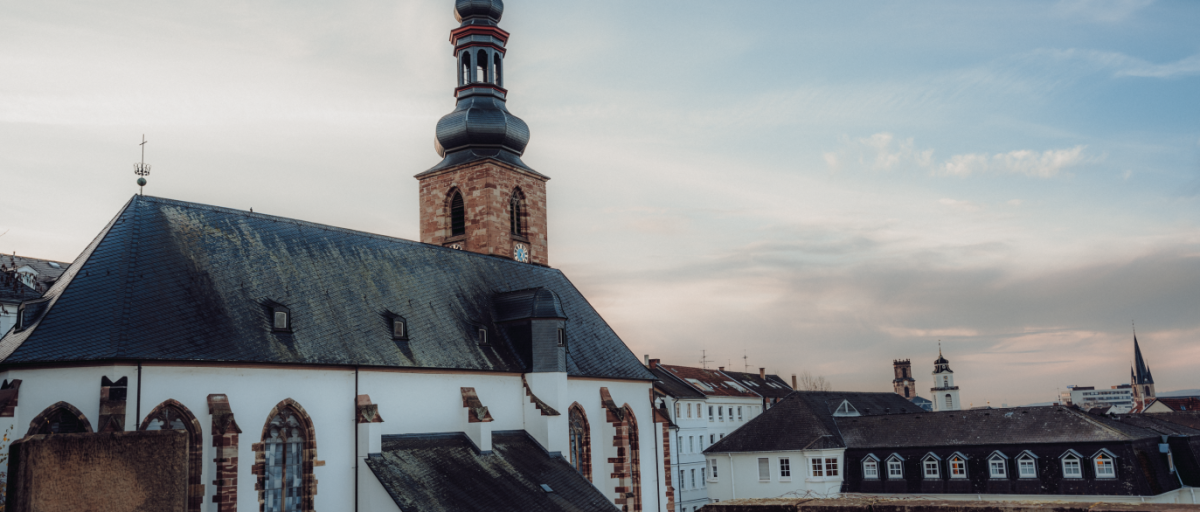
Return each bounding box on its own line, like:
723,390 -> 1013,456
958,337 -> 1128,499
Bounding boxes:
420,159 -> 550,265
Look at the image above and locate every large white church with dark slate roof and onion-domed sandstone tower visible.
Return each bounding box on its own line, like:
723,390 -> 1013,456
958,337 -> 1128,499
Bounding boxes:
0,0 -> 673,512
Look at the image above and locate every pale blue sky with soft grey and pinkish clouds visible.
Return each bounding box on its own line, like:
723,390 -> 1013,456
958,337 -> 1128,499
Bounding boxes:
0,0 -> 1200,406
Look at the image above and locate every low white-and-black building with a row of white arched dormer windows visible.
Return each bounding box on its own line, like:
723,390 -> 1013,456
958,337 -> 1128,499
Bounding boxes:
706,392 -> 1200,502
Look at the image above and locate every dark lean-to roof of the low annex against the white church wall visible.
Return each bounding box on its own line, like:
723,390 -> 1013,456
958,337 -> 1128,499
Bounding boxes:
366,432 -> 617,512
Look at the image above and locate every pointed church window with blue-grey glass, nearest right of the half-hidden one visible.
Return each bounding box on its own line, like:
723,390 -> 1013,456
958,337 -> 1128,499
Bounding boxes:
253,398 -> 317,512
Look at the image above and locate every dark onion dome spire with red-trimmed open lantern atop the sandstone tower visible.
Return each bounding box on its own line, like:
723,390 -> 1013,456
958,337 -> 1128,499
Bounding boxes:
421,0 -> 536,174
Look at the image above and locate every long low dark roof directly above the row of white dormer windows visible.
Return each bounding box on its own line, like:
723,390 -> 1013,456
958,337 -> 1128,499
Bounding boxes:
838,406 -> 1158,448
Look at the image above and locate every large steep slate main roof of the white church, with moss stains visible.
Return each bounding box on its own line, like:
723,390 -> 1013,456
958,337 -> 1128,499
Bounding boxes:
0,195 -> 654,380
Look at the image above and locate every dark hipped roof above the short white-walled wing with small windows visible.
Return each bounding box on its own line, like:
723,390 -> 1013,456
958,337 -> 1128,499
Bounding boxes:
704,391 -> 846,453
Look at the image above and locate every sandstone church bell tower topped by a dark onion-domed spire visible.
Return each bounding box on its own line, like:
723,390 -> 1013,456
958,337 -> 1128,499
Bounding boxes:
415,0 -> 550,265
